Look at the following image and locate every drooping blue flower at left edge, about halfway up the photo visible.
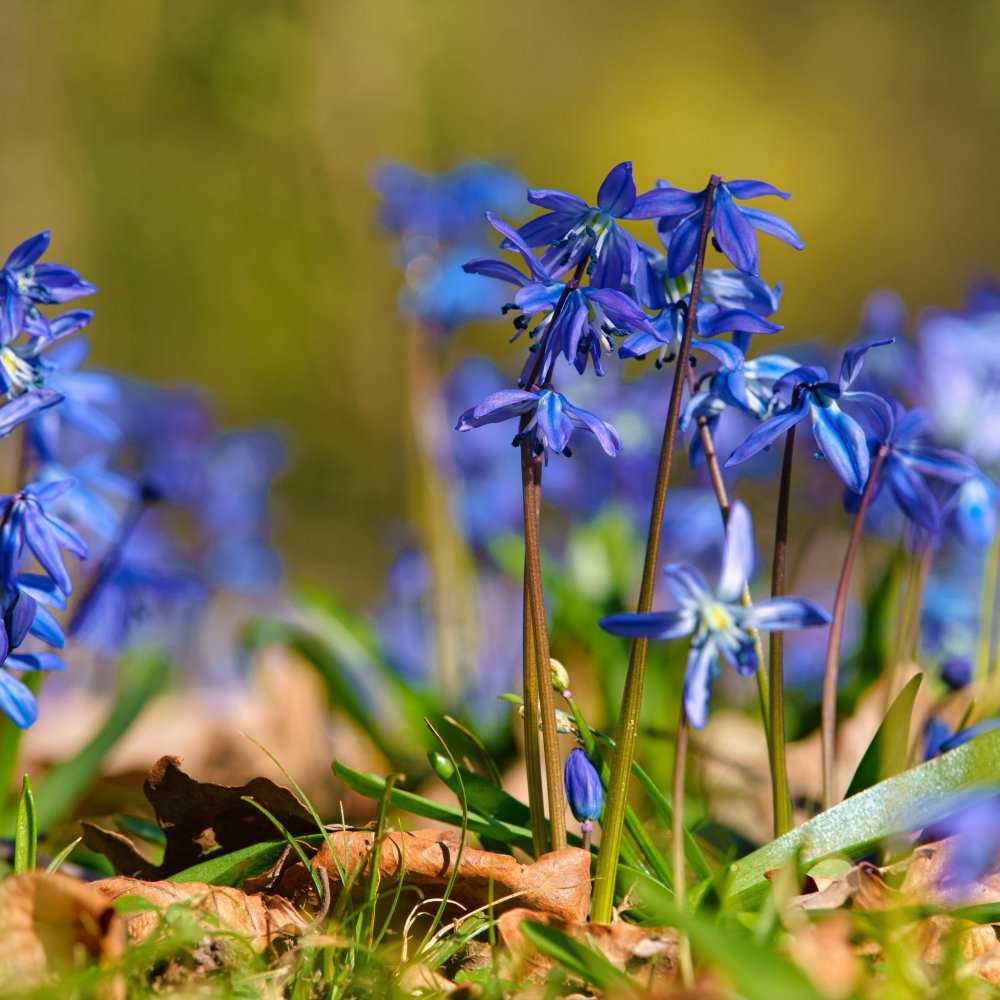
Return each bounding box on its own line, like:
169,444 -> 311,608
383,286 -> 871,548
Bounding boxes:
0,480 -> 87,594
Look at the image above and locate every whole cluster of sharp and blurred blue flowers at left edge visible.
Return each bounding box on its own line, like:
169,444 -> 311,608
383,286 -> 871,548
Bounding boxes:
0,232 -> 282,728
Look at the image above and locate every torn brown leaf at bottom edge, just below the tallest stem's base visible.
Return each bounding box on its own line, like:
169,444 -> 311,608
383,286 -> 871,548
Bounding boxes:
497,907 -> 677,996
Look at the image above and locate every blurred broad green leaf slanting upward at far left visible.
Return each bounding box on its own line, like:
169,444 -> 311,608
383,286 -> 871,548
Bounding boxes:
24,650 -> 167,830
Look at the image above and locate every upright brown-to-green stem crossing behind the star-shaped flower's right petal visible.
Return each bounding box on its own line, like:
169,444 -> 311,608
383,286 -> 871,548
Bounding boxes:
768,424 -> 795,837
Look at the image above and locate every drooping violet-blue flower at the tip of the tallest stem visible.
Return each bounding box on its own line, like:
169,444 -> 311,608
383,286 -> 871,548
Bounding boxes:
629,180 -> 805,275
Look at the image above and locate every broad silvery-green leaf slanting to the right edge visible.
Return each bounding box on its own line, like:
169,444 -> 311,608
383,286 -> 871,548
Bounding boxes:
725,729 -> 1000,909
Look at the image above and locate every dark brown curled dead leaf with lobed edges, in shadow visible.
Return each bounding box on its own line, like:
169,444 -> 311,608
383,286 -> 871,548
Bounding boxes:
84,757 -> 316,881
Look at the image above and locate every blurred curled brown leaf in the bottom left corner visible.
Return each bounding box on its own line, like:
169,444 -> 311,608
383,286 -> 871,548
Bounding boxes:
0,872 -> 125,995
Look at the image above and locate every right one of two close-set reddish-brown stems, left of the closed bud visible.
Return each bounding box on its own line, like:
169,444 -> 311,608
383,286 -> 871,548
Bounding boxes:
521,439 -> 566,851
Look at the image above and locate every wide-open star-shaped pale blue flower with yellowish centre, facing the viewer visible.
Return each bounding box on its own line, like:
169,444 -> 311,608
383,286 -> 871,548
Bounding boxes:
599,501 -> 831,729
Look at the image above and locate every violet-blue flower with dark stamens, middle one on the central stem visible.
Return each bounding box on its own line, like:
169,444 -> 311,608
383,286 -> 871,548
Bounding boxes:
465,213 -> 656,385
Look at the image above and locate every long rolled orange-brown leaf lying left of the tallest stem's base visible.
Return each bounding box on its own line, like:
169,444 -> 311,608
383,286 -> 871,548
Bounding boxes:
277,830 -> 590,920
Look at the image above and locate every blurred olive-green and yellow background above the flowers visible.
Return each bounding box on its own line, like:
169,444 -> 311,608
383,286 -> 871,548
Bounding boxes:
0,0 -> 1000,600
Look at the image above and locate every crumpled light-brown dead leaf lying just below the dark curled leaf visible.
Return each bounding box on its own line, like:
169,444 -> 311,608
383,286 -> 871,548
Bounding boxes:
92,876 -> 310,951
